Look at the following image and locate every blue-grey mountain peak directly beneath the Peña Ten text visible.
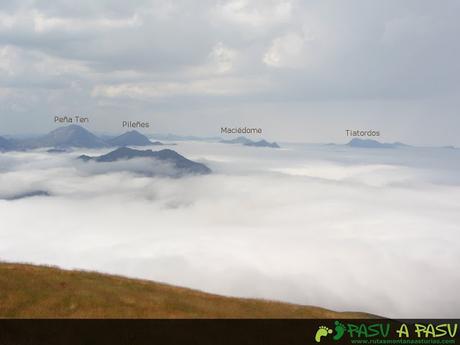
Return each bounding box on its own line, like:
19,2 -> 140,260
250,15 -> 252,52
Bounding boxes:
21,125 -> 107,148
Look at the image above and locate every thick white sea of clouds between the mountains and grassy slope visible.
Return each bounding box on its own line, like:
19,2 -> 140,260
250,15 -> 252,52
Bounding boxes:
0,142 -> 460,317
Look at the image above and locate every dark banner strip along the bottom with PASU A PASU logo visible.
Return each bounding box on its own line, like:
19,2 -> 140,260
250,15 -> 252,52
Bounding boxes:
0,319 -> 460,345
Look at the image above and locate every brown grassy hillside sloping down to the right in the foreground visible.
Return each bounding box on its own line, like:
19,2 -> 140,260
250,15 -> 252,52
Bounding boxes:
0,263 -> 369,318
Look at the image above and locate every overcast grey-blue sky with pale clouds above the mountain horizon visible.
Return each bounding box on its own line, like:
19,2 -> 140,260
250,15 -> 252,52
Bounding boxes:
0,0 -> 460,145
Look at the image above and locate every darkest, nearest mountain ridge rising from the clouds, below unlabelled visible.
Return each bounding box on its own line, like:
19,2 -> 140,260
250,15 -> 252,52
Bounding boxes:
78,147 -> 211,176
